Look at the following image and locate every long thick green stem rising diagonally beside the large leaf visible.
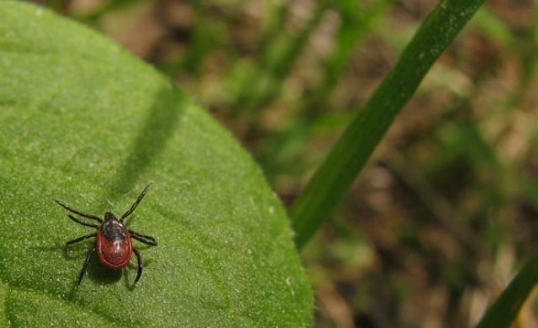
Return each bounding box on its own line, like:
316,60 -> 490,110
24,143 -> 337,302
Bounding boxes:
290,0 -> 483,248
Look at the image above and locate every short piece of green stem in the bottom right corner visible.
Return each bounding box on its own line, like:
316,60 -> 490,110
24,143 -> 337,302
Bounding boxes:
476,252 -> 538,328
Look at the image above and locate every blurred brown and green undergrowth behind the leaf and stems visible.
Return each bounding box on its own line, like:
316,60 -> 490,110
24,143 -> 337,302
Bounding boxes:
33,0 -> 538,327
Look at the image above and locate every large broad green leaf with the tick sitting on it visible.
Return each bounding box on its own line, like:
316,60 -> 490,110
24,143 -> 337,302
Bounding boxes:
0,1 -> 313,327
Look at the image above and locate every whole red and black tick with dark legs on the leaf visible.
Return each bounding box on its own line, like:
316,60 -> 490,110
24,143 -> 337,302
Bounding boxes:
54,184 -> 157,285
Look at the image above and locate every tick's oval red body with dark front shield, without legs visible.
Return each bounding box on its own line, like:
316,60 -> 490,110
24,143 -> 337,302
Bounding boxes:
96,215 -> 133,269
